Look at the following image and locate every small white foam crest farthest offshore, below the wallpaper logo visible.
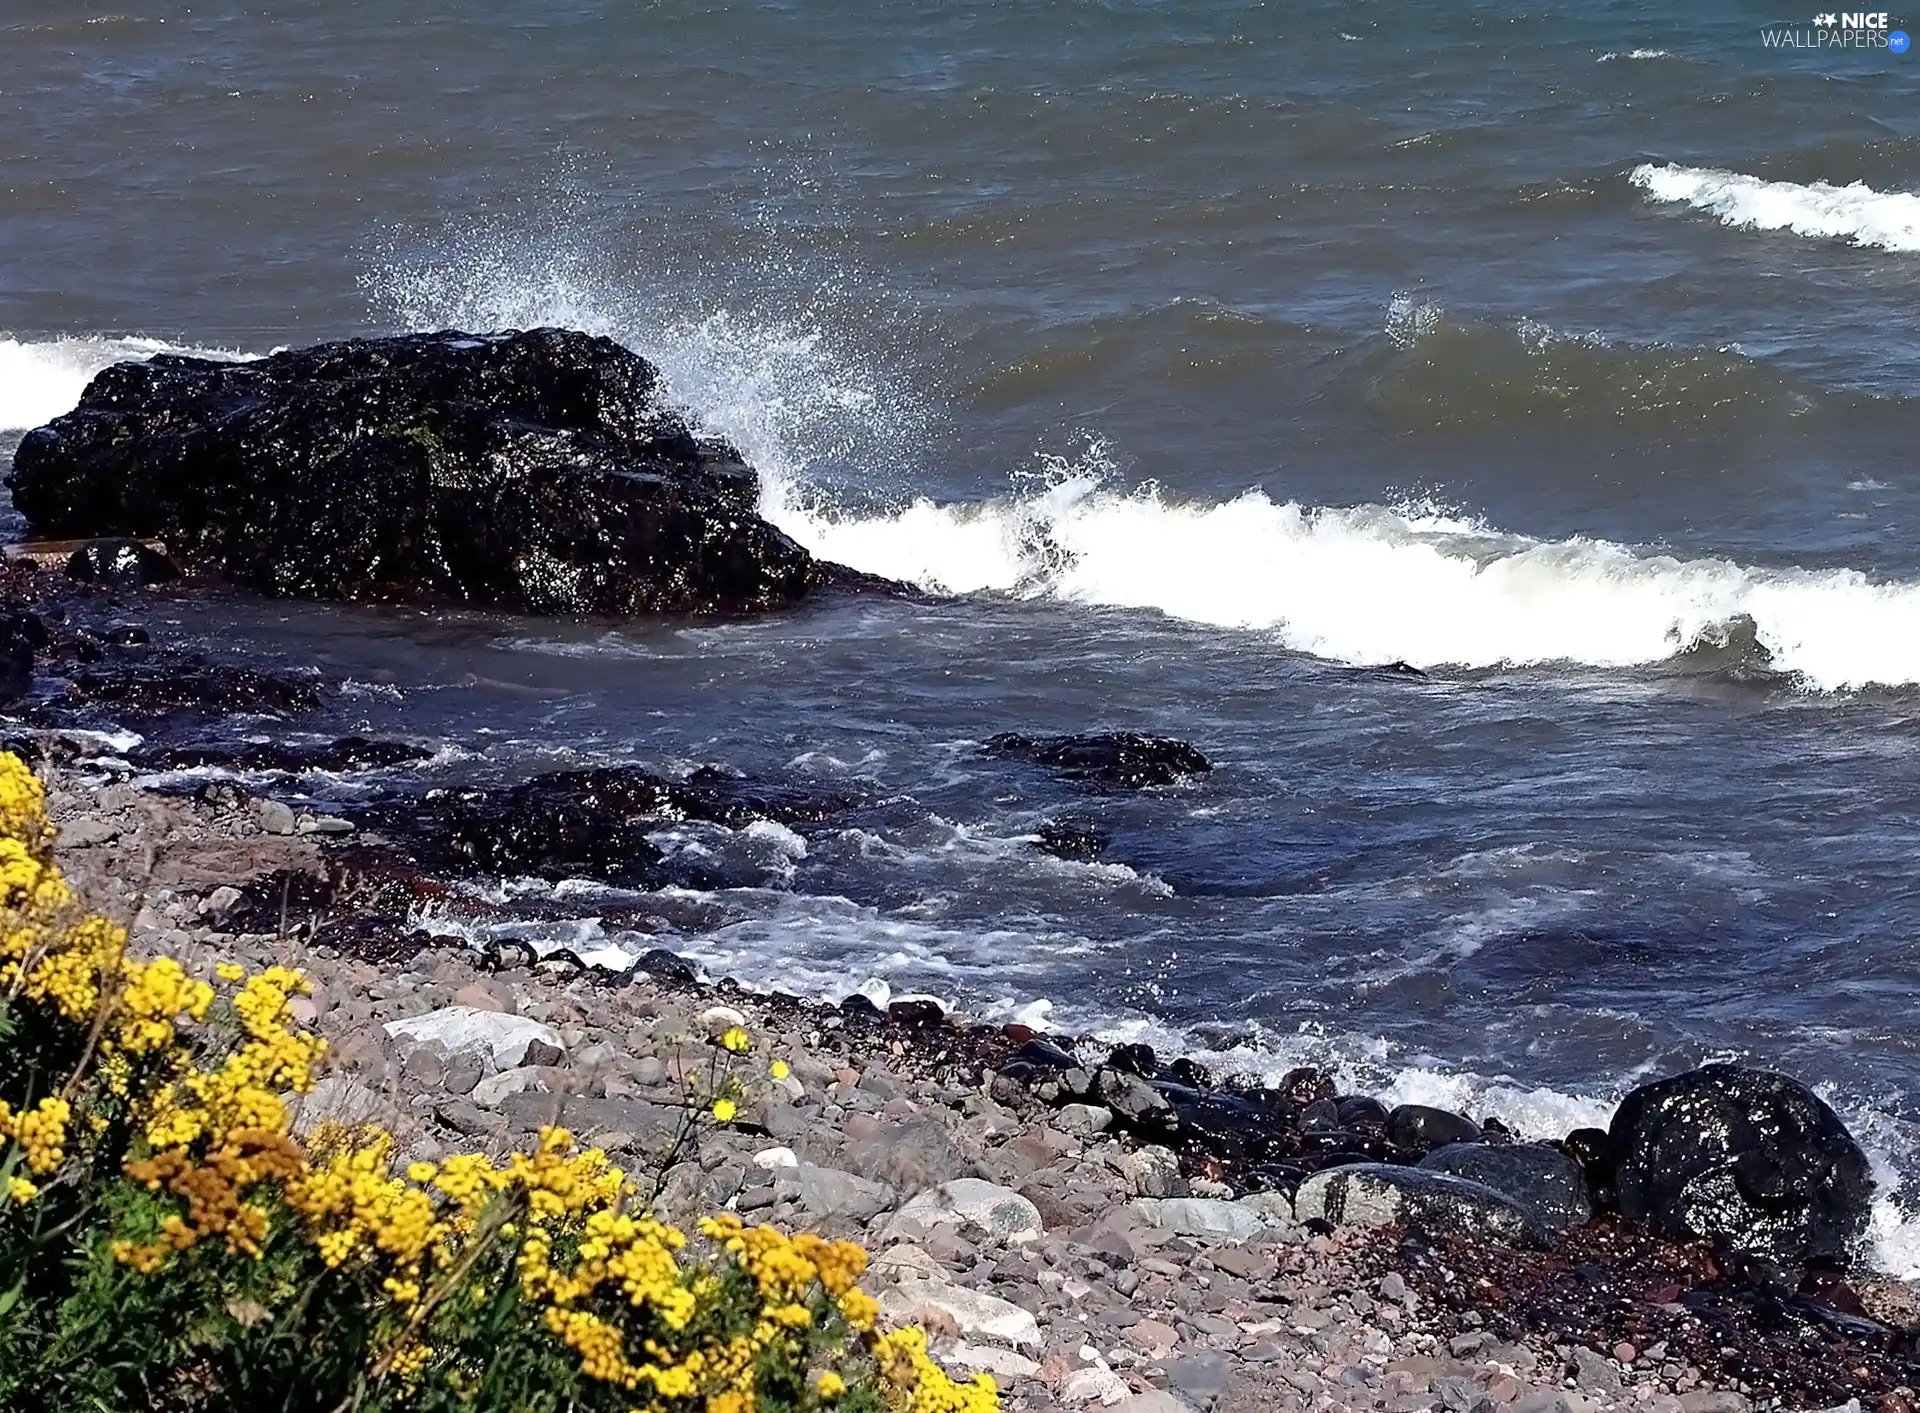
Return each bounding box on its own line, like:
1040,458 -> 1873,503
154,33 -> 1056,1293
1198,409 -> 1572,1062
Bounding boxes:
1628,161 -> 1920,251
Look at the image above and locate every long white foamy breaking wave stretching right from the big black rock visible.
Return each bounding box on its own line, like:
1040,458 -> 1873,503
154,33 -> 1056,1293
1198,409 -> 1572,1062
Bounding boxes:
764,468 -> 1920,691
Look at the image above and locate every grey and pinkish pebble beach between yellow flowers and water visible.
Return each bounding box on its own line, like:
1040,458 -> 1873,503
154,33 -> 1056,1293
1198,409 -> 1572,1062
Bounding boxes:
11,737 -> 1920,1413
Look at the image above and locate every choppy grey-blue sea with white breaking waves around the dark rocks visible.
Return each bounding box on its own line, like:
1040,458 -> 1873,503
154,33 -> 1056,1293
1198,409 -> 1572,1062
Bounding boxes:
11,0 -> 1920,1269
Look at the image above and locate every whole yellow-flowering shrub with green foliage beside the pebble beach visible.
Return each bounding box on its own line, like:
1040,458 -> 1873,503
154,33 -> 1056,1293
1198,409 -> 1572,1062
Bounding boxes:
0,754 -> 998,1413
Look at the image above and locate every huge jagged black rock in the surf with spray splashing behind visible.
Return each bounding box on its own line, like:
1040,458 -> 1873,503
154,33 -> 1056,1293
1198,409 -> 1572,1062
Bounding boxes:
8,328 -> 877,614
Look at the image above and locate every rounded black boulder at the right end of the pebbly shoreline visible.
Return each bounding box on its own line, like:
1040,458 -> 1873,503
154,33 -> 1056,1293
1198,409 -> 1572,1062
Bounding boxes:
1609,1064 -> 1874,1286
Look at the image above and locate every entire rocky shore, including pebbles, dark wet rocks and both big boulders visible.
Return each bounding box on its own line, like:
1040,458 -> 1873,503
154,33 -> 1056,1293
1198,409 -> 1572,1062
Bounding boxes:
0,330 -> 1920,1413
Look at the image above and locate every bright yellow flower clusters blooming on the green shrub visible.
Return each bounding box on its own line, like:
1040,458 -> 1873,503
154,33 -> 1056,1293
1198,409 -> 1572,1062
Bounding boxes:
0,753 -> 998,1413
